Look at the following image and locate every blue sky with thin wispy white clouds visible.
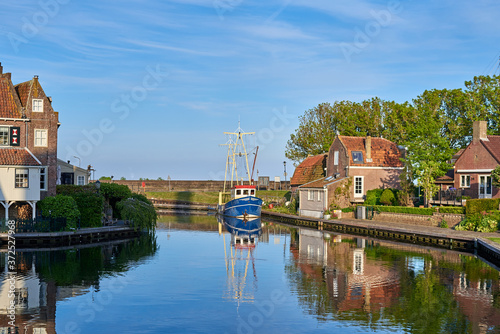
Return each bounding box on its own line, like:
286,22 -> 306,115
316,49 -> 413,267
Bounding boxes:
0,0 -> 500,180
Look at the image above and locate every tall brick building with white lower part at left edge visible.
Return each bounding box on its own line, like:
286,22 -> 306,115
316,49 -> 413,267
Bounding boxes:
0,64 -> 60,219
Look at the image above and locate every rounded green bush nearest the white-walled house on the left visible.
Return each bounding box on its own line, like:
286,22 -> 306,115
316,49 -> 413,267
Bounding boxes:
38,195 -> 80,228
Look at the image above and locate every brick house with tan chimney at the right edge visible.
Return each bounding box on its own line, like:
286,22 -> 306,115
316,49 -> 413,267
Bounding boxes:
454,121 -> 500,198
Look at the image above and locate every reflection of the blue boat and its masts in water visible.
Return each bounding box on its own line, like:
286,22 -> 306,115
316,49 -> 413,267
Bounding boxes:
217,215 -> 262,305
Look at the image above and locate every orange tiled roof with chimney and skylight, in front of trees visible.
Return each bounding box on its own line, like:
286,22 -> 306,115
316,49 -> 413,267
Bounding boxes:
337,136 -> 403,167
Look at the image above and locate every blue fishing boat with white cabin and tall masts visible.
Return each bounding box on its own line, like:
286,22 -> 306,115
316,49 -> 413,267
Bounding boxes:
217,126 -> 262,221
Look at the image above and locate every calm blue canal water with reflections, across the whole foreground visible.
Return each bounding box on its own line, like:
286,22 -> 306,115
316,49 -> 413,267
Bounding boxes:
0,217 -> 500,334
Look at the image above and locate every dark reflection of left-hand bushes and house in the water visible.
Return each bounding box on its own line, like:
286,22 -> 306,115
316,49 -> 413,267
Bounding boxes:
0,234 -> 158,334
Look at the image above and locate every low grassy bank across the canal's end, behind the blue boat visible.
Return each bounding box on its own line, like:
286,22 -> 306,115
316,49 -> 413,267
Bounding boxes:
146,190 -> 290,204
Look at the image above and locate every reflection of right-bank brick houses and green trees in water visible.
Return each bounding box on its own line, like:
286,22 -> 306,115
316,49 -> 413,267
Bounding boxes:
285,229 -> 500,333
